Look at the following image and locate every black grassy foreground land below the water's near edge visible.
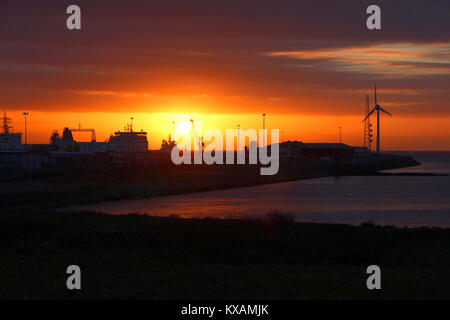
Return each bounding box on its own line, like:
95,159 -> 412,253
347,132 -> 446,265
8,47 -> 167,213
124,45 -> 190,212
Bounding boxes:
0,210 -> 450,299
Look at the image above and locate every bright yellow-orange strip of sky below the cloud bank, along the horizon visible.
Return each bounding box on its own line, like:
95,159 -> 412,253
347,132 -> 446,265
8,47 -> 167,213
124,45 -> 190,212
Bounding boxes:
8,111 -> 450,150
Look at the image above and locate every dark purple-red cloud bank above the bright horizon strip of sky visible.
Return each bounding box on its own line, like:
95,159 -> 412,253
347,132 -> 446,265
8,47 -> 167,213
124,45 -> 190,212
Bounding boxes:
0,0 -> 450,115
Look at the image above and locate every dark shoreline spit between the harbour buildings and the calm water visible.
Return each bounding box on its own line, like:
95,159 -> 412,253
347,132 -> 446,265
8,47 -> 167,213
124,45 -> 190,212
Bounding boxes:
0,151 -> 420,209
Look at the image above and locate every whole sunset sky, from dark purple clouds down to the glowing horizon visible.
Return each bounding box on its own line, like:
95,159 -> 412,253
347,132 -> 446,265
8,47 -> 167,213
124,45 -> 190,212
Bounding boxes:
0,0 -> 450,150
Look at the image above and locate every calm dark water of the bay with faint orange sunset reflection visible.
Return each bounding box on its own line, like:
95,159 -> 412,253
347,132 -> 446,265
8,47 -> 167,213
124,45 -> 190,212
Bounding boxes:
70,152 -> 450,227
